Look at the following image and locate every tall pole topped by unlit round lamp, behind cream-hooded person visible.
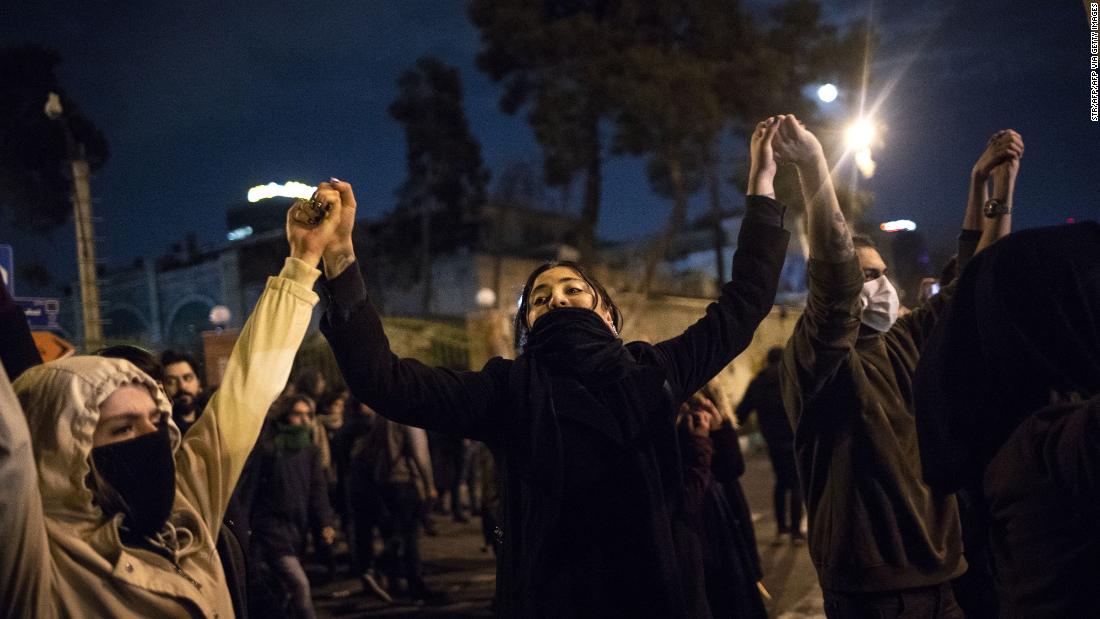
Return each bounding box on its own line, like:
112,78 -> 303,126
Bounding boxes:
45,92 -> 103,352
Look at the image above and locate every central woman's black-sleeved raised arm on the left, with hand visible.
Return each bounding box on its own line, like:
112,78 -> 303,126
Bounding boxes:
321,180 -> 509,441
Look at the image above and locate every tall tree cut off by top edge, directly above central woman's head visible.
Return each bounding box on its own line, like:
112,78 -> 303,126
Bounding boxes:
469,0 -> 633,258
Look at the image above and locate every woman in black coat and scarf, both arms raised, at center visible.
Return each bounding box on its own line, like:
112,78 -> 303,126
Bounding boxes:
321,121 -> 789,618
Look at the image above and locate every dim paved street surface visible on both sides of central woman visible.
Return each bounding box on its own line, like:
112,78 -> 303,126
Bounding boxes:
311,444 -> 824,619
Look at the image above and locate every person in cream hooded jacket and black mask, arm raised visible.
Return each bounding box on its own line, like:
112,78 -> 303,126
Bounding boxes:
0,184 -> 350,619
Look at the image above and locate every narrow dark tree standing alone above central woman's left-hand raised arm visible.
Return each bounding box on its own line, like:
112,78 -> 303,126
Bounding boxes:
389,56 -> 488,313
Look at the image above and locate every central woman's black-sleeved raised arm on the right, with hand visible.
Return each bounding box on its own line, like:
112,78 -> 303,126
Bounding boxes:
655,117 -> 791,401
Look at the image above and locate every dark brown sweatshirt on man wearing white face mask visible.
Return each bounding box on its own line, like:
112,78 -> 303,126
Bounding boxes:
781,258 -> 966,592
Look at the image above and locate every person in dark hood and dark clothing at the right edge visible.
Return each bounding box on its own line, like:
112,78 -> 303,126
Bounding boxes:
915,222 -> 1100,617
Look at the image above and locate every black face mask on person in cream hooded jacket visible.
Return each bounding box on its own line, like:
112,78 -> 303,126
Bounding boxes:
91,424 -> 176,540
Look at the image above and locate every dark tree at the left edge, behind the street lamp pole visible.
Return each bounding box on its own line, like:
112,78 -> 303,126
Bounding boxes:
0,45 -> 108,232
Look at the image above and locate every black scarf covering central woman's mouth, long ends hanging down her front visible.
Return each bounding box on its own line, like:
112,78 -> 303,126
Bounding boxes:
505,308 -> 682,616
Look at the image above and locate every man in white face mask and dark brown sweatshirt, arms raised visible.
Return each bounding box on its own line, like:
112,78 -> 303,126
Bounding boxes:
774,117 -> 1023,618
